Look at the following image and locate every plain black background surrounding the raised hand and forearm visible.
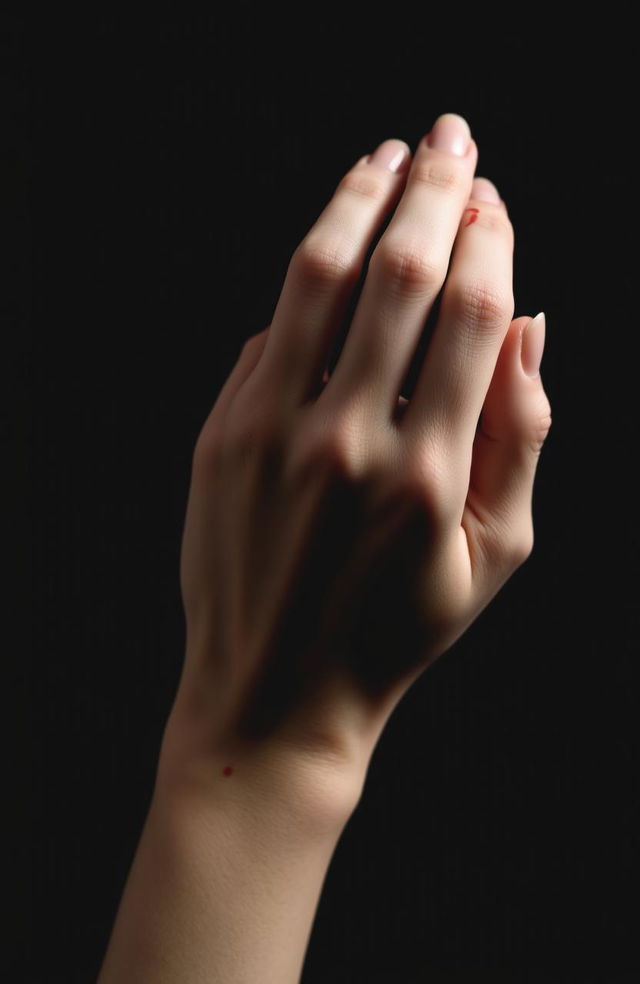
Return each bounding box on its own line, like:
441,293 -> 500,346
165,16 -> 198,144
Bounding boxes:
15,4 -> 640,984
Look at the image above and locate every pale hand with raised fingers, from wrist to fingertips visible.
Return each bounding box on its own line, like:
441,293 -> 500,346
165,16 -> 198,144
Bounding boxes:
162,114 -> 551,808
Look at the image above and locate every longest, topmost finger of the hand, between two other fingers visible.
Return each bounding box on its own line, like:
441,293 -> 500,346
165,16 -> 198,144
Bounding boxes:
323,113 -> 478,416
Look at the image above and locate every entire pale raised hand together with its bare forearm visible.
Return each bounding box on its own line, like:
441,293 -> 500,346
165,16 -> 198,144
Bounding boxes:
99,113 -> 551,984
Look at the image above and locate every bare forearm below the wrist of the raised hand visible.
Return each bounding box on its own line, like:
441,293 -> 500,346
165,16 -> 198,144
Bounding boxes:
98,712 -> 362,984
